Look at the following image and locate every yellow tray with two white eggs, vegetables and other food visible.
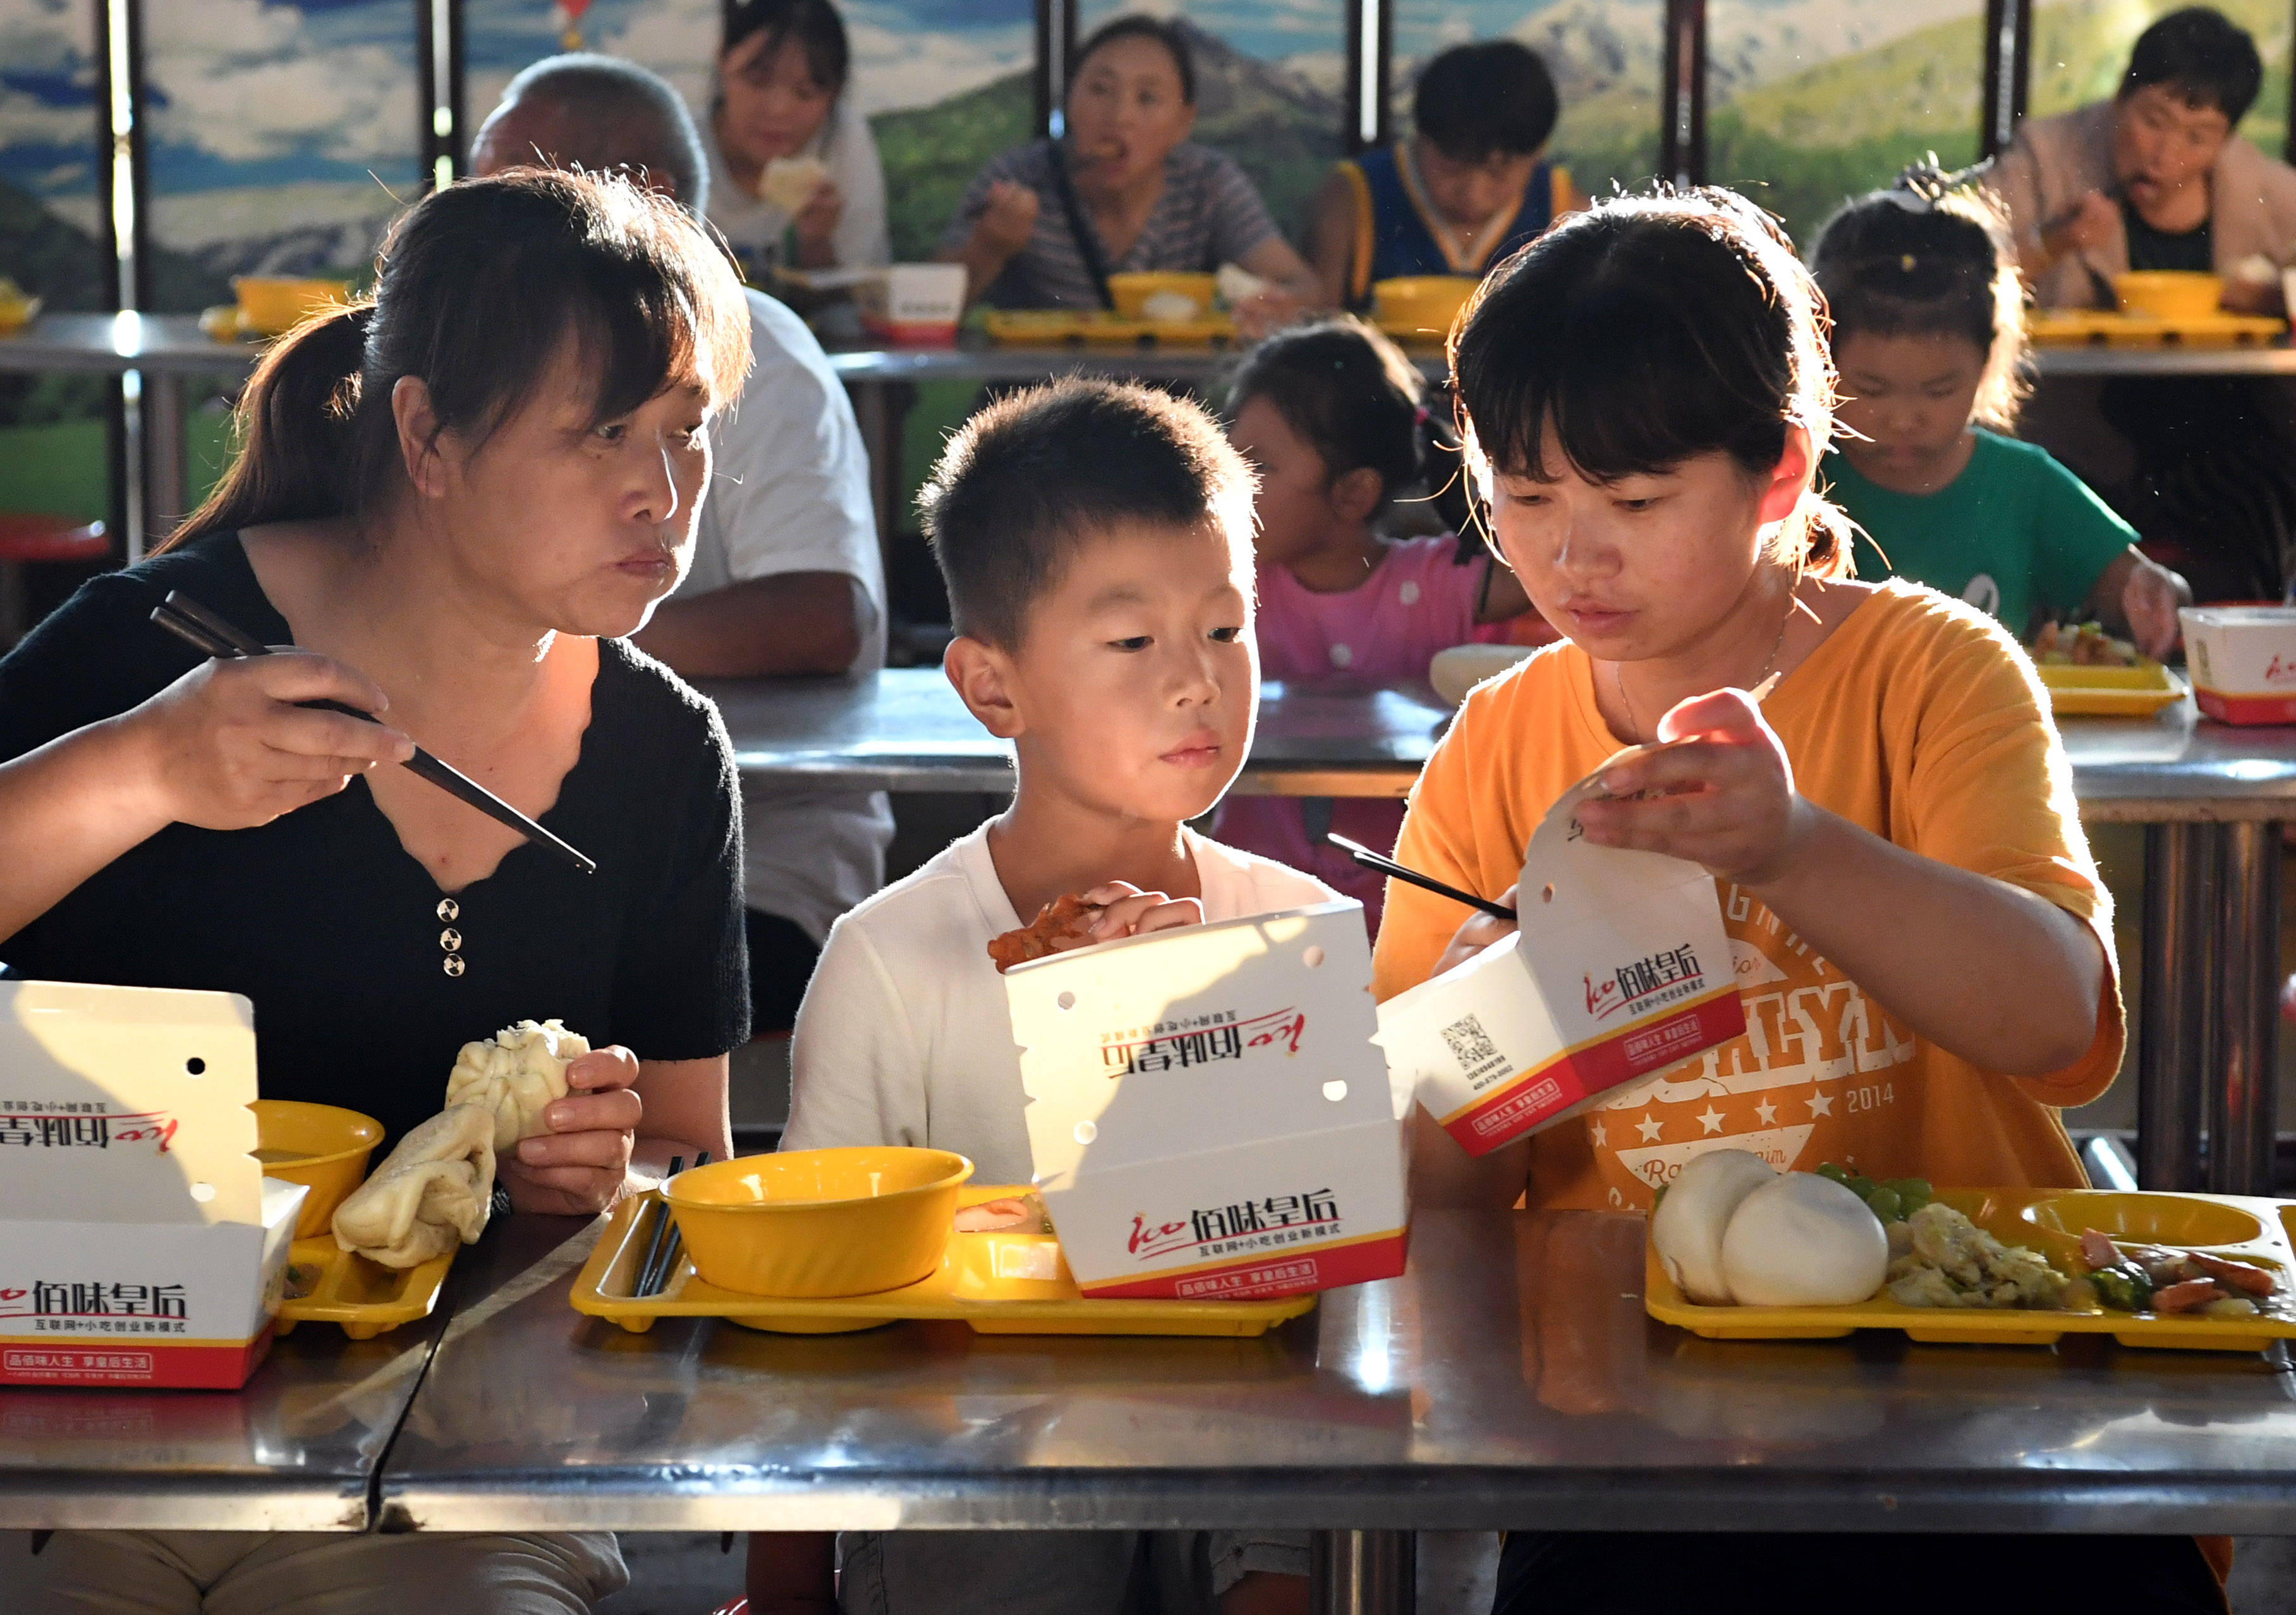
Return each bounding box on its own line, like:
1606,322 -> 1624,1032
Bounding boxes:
1644,1149 -> 2296,1351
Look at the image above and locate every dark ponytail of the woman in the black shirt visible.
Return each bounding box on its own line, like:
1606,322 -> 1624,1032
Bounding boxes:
159,303 -> 374,550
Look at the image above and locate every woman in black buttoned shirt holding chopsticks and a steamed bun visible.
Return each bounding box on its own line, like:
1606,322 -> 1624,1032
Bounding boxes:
0,170 -> 748,1611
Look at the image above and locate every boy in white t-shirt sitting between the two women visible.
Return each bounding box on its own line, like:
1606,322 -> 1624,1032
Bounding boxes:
751,381 -> 1334,1615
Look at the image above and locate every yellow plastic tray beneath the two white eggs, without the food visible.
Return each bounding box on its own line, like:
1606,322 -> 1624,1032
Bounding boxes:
1642,1189 -> 2296,1351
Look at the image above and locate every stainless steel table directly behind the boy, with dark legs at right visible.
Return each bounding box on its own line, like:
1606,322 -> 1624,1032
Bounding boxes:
710,668 -> 2296,1193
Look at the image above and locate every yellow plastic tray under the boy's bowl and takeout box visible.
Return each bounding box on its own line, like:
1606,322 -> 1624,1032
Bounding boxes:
574,1183 -> 1316,1335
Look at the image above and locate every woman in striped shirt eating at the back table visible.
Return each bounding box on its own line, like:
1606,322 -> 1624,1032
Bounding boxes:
939,16 -> 1318,332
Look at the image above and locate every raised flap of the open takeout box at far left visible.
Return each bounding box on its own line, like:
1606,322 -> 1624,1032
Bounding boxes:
0,982 -> 264,1227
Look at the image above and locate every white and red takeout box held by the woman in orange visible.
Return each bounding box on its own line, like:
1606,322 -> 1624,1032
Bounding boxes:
1378,771 -> 1745,1156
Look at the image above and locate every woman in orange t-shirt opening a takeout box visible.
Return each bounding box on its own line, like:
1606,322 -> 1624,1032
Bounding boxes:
1375,190 -> 2223,1612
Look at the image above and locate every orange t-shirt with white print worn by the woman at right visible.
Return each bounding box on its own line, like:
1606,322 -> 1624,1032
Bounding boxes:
1373,583 -> 2126,1207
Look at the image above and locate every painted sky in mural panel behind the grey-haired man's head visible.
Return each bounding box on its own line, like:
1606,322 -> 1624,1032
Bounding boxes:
464,0 -> 1033,119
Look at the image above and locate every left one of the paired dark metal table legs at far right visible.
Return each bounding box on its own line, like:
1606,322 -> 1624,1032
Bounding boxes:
2137,823 -> 2218,1190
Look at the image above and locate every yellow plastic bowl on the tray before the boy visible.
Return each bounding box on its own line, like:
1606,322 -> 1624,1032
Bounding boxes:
661,1147 -> 973,1298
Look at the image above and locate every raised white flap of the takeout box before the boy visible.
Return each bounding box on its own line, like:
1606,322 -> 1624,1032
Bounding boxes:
1004,902 -> 1394,1189
